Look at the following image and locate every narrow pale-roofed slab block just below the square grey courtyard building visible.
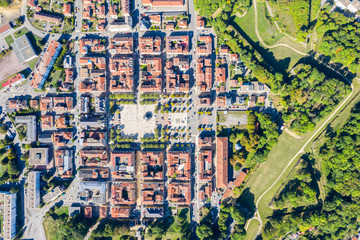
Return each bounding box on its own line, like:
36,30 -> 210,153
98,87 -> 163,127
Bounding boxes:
27,171 -> 40,208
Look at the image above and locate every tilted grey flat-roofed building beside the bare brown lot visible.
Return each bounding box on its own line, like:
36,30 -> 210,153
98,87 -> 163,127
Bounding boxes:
11,34 -> 37,63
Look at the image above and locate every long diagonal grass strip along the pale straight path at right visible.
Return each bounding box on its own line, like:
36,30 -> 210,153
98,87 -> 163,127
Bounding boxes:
243,78 -> 360,229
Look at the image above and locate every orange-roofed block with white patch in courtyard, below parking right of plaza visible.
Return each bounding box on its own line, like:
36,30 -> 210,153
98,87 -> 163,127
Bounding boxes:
167,151 -> 191,181
